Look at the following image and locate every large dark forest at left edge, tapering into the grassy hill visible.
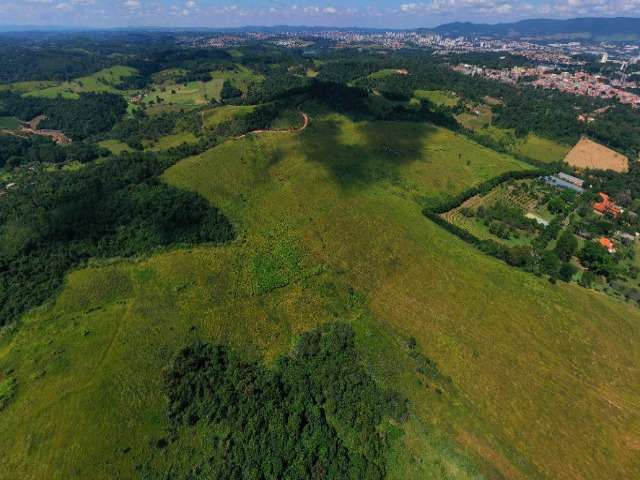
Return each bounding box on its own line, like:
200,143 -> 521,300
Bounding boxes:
0,154 -> 233,324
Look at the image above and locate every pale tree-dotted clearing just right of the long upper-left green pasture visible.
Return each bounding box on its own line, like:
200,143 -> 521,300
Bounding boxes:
144,80 -> 222,108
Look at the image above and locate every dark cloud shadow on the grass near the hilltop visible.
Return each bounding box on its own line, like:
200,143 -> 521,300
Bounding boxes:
301,119 -> 436,188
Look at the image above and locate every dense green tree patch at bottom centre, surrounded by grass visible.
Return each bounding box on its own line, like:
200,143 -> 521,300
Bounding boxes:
166,323 -> 406,480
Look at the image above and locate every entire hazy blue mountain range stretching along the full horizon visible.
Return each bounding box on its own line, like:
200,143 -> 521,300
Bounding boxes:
0,17 -> 640,42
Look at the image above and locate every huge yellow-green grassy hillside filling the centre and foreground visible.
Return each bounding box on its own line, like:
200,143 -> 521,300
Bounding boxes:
0,115 -> 640,479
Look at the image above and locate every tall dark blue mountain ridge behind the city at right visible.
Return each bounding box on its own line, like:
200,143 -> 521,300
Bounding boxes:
430,17 -> 640,41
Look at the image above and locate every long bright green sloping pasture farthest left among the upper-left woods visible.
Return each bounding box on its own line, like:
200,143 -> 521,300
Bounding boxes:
25,66 -> 136,99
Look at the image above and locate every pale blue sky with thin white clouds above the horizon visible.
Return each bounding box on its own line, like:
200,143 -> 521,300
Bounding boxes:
0,0 -> 640,28
